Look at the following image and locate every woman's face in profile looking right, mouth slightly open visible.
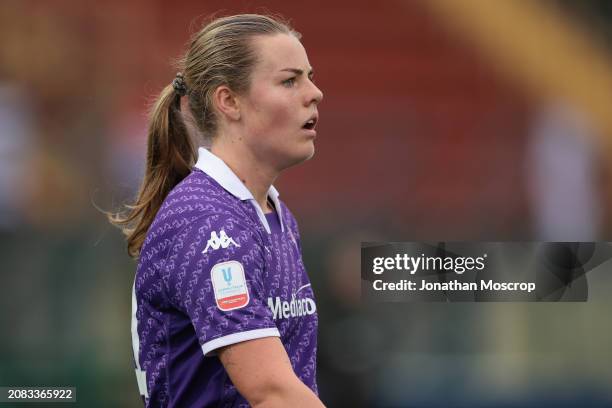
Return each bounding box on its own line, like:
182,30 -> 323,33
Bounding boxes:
239,34 -> 323,171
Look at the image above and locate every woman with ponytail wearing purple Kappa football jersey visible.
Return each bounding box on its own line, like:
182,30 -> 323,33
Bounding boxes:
113,15 -> 323,407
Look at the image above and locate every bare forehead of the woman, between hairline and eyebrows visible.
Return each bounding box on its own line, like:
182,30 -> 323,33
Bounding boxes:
252,34 -> 310,75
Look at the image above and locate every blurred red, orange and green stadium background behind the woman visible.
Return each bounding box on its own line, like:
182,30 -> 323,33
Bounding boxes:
0,0 -> 612,407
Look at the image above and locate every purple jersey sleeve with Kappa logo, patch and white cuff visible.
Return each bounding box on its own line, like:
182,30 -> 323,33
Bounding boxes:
166,214 -> 280,356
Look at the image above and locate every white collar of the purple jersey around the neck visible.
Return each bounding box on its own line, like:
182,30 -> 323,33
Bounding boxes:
195,147 -> 285,234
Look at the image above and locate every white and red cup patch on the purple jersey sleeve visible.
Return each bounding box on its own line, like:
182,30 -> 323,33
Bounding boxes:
210,261 -> 249,312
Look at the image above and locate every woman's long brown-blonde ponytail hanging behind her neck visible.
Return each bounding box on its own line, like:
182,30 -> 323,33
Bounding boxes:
108,81 -> 196,258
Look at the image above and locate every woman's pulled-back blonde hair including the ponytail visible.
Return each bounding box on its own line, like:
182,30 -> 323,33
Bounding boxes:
112,14 -> 300,257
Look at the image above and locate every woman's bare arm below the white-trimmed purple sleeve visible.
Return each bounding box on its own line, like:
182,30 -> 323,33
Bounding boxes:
219,337 -> 324,408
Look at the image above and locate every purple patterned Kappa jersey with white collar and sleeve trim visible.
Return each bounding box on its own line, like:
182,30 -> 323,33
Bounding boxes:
132,148 -> 318,407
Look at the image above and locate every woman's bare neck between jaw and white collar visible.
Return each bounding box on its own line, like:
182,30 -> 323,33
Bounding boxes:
210,137 -> 279,213
